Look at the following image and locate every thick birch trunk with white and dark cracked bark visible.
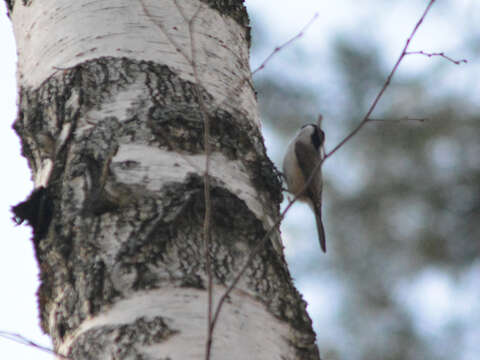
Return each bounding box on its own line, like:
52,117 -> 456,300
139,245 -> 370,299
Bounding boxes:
6,0 -> 319,359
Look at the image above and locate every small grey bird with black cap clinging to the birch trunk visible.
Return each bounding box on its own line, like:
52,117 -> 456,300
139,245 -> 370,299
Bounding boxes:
283,116 -> 327,252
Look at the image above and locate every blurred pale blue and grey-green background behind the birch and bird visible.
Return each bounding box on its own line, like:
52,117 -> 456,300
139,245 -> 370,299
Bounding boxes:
0,0 -> 480,360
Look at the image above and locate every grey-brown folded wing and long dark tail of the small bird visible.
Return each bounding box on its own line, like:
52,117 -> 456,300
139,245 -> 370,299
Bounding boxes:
295,142 -> 327,252
